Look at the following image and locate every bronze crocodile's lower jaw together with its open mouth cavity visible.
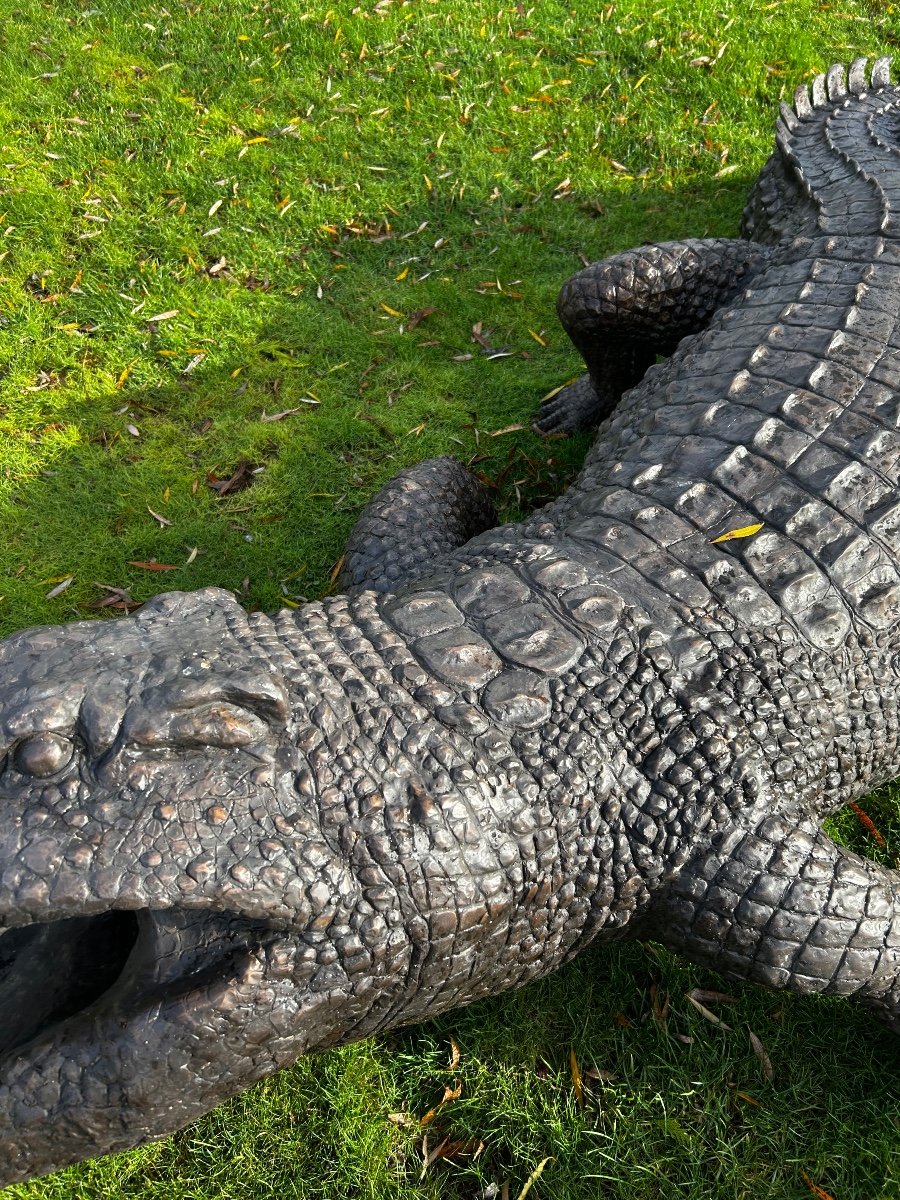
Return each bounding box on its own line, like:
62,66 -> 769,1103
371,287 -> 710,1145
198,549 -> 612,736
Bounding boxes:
0,906 -> 305,1188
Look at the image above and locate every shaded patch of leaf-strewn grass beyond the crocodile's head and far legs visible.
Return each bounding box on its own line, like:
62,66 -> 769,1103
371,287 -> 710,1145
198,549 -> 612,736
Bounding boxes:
0,176 -> 743,632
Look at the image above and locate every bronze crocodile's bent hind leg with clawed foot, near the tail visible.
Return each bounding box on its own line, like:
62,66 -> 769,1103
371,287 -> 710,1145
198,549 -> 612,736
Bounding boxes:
534,238 -> 770,433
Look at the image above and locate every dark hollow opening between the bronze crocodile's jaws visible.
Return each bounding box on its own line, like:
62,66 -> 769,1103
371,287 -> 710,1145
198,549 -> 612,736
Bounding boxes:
0,908 -> 274,1058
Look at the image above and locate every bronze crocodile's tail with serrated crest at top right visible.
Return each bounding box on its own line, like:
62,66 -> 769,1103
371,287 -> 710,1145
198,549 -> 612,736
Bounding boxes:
742,58 -> 900,244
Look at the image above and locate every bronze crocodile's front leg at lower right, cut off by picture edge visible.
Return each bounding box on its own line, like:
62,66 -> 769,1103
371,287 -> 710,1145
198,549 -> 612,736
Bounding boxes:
649,814 -> 900,1032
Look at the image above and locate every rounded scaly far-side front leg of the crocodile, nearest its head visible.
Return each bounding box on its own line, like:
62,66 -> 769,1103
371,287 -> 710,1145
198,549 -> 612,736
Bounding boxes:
340,458 -> 497,592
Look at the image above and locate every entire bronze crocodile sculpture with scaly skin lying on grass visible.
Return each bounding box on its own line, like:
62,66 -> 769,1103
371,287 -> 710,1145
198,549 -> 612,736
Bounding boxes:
0,60 -> 900,1183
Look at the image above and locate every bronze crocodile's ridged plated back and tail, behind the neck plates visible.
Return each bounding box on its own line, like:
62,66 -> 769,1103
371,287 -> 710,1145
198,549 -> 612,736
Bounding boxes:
535,60 -> 900,667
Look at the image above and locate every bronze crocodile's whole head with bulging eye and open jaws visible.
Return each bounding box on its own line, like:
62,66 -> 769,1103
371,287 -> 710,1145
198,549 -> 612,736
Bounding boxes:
0,589 -> 386,1186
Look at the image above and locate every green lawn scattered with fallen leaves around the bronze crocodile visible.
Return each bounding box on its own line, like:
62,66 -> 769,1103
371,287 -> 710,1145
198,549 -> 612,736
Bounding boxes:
0,0 -> 900,1200
